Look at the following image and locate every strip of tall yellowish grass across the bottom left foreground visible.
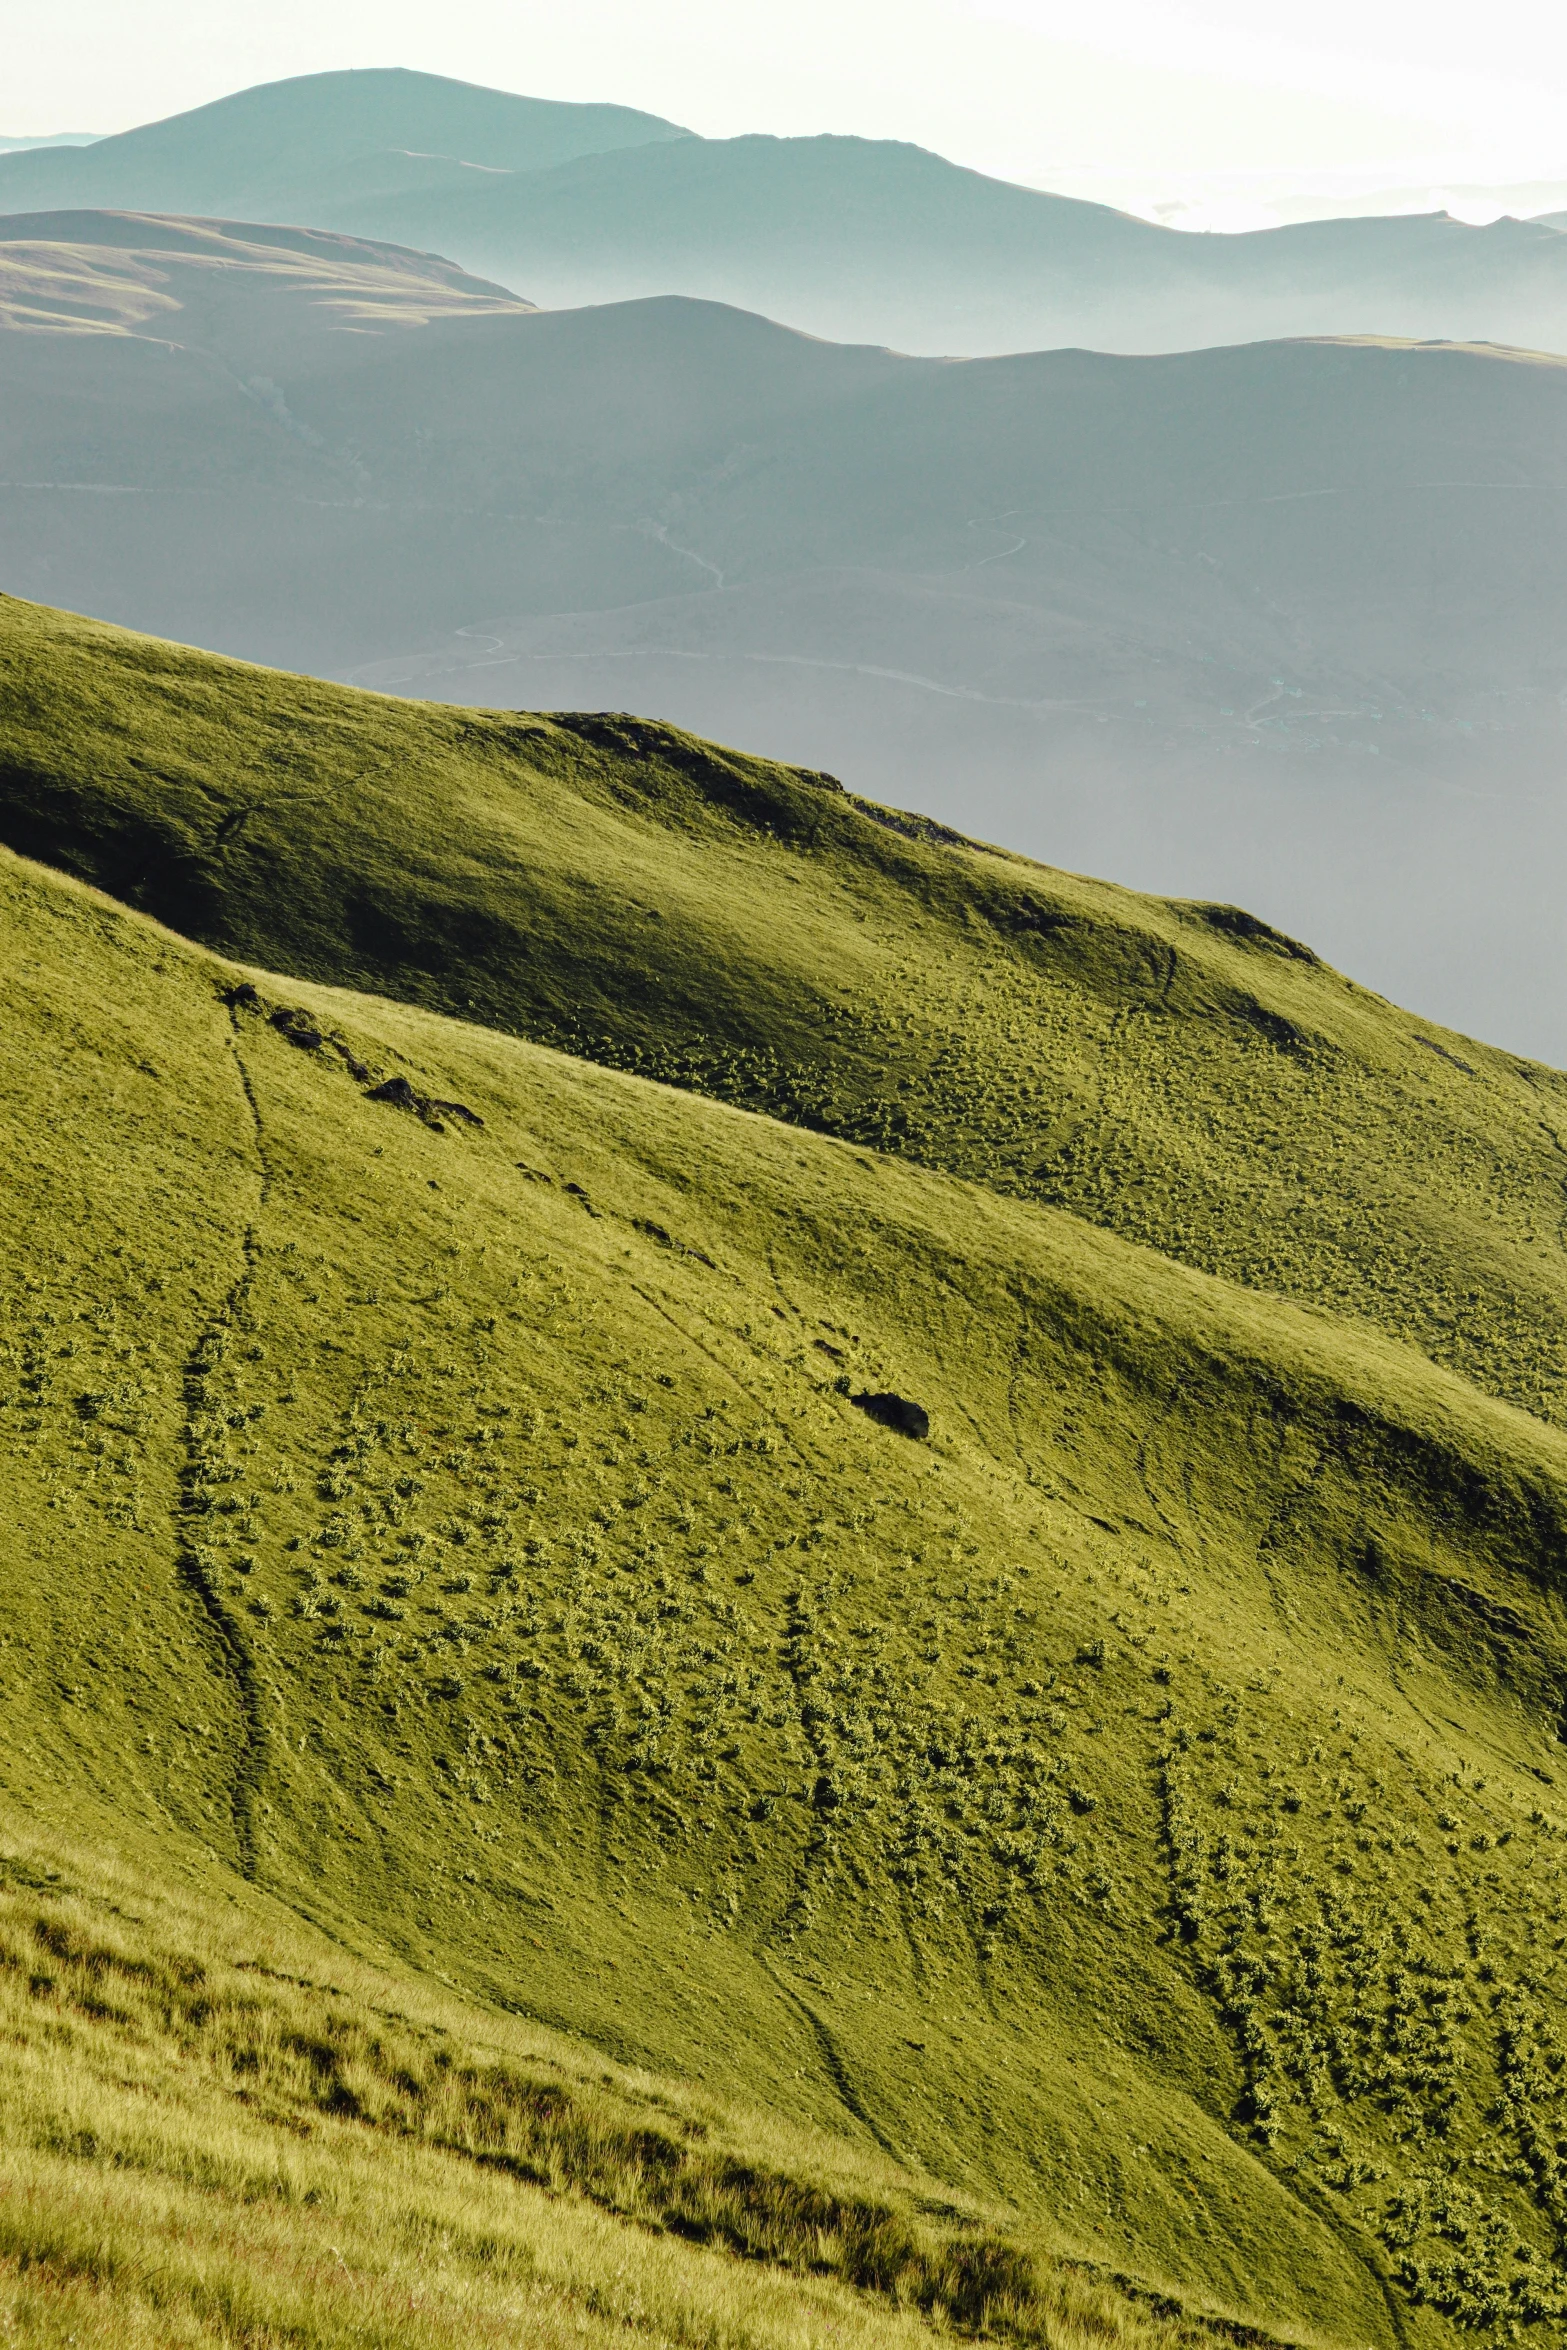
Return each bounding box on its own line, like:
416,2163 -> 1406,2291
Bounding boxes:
0,1871 -> 1296,2350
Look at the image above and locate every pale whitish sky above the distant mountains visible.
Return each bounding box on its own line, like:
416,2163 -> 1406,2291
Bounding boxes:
12,0 -> 1567,209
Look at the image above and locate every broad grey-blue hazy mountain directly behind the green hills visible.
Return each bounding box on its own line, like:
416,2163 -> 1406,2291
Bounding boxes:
0,216 -> 1567,1060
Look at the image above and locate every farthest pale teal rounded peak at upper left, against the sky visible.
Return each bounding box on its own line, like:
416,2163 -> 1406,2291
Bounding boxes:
0,66 -> 686,228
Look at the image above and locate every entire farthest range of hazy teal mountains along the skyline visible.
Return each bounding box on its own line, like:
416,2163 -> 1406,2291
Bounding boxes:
0,71 -> 1567,355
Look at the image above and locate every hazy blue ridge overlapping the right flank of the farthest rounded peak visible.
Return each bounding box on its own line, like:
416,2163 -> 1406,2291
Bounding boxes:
331,139 -> 1567,355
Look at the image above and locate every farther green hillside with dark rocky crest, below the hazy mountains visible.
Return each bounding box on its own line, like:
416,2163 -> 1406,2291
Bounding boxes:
0,602 -> 1567,1419
